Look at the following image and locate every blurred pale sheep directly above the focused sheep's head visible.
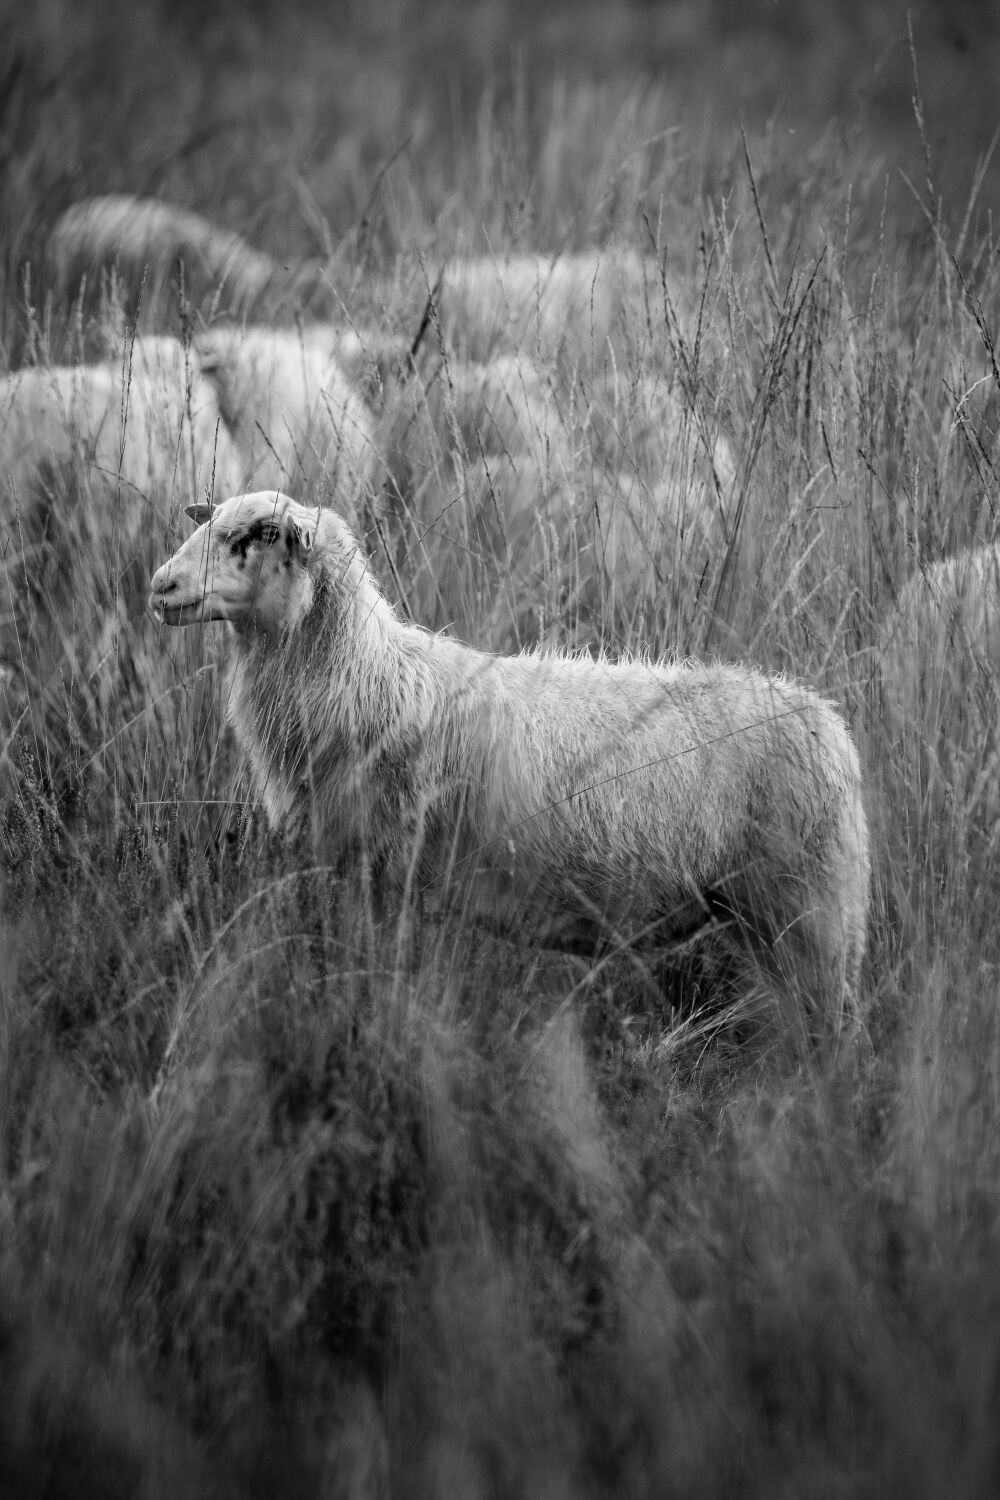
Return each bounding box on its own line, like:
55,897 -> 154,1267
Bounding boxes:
195,324 -> 375,507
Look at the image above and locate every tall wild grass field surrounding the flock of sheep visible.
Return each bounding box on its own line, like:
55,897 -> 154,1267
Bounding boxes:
0,3 -> 1000,1500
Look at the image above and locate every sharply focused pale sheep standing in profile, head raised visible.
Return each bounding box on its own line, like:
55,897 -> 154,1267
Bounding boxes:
150,492 -> 870,1019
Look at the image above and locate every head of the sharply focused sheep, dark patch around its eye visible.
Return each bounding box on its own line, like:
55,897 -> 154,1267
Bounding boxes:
150,491 -> 316,633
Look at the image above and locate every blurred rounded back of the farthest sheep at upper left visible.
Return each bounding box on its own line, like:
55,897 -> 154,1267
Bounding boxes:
46,194 -> 286,306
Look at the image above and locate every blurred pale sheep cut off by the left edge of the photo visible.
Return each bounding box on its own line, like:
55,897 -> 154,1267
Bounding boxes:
0,338 -> 246,531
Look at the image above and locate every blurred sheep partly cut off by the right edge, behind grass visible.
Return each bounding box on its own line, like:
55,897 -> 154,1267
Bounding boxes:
879,543 -> 1000,861
